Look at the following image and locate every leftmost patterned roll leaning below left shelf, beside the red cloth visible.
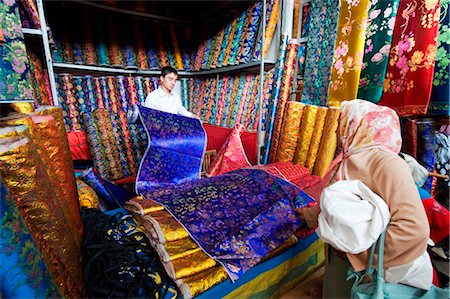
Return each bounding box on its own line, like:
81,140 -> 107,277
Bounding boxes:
83,112 -> 111,178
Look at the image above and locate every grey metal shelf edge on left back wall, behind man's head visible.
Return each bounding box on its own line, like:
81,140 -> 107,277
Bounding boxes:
53,62 -> 190,76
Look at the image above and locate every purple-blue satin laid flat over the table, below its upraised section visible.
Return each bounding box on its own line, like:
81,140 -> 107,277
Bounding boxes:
139,169 -> 312,280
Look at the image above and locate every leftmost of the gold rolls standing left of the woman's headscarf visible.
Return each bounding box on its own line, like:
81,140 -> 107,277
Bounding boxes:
276,101 -> 305,162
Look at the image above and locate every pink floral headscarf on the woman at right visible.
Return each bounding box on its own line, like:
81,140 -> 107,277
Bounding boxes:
328,100 -> 402,180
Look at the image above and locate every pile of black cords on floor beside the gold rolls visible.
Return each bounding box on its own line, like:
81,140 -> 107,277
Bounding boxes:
81,208 -> 182,298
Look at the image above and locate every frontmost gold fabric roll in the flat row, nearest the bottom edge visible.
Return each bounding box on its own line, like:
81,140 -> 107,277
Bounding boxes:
177,265 -> 228,298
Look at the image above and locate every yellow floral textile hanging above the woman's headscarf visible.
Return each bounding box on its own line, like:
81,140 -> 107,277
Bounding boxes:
328,0 -> 370,107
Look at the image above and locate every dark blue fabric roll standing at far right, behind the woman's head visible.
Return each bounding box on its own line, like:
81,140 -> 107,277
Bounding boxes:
417,118 -> 436,193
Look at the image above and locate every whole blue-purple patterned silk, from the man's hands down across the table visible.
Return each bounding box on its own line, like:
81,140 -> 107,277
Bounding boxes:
136,107 -> 314,280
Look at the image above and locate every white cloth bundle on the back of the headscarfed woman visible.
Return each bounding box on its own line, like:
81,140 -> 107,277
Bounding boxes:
316,180 -> 391,254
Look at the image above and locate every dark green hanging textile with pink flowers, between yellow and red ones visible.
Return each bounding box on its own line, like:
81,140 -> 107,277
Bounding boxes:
358,0 -> 399,104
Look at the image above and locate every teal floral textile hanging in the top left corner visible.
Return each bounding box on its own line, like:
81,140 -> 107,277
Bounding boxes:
0,0 -> 34,103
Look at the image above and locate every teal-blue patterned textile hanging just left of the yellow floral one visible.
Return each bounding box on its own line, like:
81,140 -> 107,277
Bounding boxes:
301,0 -> 339,106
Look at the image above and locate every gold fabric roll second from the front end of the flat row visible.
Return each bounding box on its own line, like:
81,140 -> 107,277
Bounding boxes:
168,251 -> 217,279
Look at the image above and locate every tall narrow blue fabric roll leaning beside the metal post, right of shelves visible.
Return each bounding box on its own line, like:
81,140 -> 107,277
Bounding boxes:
263,35 -> 288,164
